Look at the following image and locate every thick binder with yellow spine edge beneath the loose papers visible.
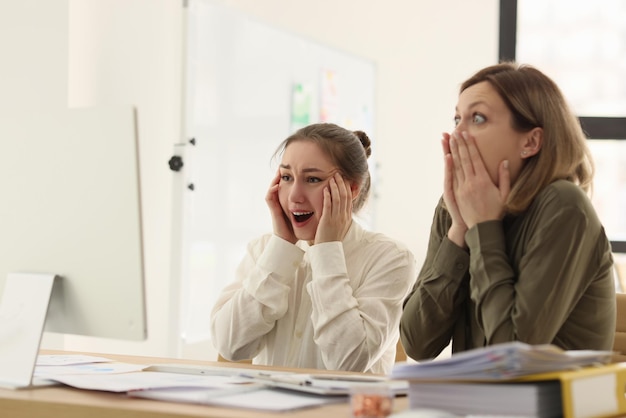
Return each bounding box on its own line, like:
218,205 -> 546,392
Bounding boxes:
408,362 -> 626,418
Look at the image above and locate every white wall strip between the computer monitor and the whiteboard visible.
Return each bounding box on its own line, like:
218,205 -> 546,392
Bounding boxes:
58,0 -> 182,355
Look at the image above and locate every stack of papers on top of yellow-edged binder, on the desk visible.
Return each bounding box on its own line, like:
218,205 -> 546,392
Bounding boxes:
391,342 -> 626,418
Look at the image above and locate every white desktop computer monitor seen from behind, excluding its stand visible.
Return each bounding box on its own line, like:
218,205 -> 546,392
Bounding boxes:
0,106 -> 147,340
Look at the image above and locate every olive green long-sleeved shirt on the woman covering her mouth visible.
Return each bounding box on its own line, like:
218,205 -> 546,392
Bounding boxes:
400,180 -> 615,360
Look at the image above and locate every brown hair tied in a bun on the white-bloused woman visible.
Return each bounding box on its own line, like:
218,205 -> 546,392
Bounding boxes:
274,123 -> 372,213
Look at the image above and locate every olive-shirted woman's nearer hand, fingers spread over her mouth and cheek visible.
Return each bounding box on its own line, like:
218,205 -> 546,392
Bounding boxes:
450,132 -> 509,228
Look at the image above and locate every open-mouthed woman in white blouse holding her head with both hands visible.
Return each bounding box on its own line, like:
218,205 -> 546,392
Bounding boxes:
211,123 -> 416,373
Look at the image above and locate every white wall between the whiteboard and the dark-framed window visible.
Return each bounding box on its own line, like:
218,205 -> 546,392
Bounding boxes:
221,0 -> 499,280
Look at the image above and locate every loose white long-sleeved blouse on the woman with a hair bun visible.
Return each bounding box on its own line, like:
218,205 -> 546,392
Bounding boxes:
211,221 -> 416,374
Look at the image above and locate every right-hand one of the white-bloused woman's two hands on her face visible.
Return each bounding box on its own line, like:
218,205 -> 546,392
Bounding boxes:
315,173 -> 352,244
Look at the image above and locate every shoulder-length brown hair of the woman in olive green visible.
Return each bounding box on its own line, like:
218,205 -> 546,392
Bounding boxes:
460,62 -> 594,213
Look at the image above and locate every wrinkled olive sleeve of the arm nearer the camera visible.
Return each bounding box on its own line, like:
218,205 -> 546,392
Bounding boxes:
466,200 -> 597,344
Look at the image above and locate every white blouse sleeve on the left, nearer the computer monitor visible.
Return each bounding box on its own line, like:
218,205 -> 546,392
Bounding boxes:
211,235 -> 304,360
